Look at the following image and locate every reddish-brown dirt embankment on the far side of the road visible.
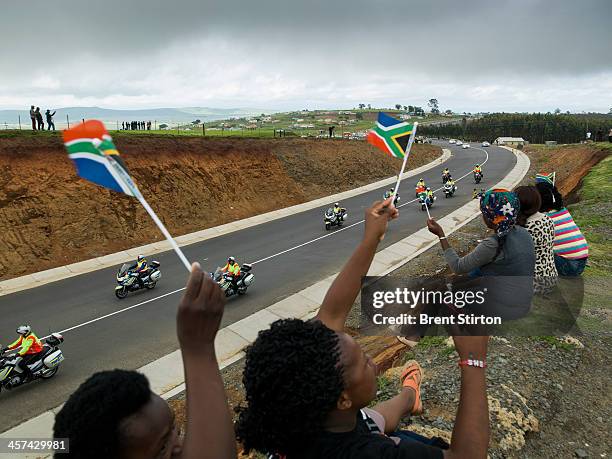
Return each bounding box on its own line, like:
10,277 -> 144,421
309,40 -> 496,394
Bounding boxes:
0,136 -> 441,280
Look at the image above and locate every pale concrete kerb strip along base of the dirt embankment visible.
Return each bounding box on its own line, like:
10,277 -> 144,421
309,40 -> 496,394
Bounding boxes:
0,148 -> 451,296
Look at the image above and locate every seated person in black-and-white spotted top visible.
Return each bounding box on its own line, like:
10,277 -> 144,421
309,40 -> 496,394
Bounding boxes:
514,186 -> 558,293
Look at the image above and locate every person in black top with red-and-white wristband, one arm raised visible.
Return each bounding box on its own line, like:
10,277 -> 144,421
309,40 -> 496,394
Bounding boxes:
236,198 -> 489,459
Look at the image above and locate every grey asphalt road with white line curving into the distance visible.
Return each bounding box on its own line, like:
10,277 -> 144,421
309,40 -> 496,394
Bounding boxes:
0,142 -> 516,432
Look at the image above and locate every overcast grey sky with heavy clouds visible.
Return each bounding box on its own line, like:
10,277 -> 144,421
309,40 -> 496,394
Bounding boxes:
0,0 -> 612,112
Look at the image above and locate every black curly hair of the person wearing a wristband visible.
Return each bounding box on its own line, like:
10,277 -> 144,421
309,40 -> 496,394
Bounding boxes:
236,319 -> 344,455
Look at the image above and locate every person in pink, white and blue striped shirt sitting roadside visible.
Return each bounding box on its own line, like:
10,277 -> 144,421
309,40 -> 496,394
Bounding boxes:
536,182 -> 589,276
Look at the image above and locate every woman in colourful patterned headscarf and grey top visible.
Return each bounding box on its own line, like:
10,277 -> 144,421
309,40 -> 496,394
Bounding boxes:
427,188 -> 535,319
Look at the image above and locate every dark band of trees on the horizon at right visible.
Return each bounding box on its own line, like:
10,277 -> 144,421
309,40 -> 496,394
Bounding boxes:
419,113 -> 612,143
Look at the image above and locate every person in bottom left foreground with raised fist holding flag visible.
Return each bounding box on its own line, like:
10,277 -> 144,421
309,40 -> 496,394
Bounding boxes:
53,263 -> 236,459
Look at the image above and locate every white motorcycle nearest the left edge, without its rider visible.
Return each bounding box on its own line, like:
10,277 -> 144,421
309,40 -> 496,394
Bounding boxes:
0,333 -> 64,390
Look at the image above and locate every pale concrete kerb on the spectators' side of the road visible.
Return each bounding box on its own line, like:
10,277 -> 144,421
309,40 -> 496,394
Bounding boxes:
0,149 -> 530,438
